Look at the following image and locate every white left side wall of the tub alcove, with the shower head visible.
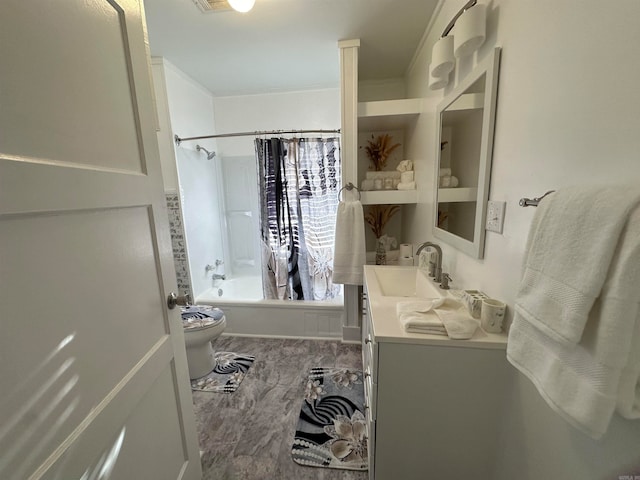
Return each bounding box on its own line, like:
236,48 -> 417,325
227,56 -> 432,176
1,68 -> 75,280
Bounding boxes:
154,60 -> 223,298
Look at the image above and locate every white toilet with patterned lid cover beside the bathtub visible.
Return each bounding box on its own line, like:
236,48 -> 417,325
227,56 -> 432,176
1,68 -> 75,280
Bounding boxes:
182,305 -> 227,379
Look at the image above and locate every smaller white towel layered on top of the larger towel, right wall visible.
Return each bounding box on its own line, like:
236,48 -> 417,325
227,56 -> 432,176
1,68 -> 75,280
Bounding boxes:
516,186 -> 640,344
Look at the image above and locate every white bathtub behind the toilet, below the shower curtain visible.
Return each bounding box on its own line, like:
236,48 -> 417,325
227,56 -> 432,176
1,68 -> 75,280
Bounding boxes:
196,276 -> 344,339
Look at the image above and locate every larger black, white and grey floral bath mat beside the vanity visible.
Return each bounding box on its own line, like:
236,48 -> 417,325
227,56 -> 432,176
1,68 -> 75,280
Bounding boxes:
291,368 -> 368,470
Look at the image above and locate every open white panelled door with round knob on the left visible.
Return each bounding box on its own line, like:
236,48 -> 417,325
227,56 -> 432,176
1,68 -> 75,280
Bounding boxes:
0,0 -> 201,480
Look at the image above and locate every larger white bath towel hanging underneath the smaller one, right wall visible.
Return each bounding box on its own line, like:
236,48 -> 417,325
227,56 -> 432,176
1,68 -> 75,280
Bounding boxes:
507,196 -> 640,438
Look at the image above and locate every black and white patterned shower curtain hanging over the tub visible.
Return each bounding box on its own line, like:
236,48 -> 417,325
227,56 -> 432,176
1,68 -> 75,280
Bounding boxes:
255,138 -> 341,300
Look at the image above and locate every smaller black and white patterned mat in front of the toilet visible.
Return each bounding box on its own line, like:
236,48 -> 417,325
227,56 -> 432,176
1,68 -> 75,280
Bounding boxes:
191,352 -> 256,393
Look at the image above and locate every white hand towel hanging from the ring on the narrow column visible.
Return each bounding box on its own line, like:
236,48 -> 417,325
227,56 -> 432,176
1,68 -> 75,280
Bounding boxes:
333,200 -> 366,285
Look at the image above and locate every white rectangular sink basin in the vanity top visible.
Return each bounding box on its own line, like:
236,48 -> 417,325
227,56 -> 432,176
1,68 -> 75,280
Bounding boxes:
369,265 -> 445,298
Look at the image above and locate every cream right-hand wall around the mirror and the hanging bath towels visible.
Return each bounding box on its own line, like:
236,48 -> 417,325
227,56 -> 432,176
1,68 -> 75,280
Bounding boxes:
405,0 -> 640,480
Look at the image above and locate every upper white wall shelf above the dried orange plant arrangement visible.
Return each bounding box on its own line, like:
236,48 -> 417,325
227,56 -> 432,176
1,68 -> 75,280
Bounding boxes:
358,98 -> 422,131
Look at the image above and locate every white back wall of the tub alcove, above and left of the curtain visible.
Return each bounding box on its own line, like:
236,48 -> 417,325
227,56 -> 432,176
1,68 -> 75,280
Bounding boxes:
214,89 -> 340,276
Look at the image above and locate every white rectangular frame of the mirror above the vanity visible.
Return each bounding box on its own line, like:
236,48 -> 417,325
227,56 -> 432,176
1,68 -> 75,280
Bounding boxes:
431,47 -> 500,259
